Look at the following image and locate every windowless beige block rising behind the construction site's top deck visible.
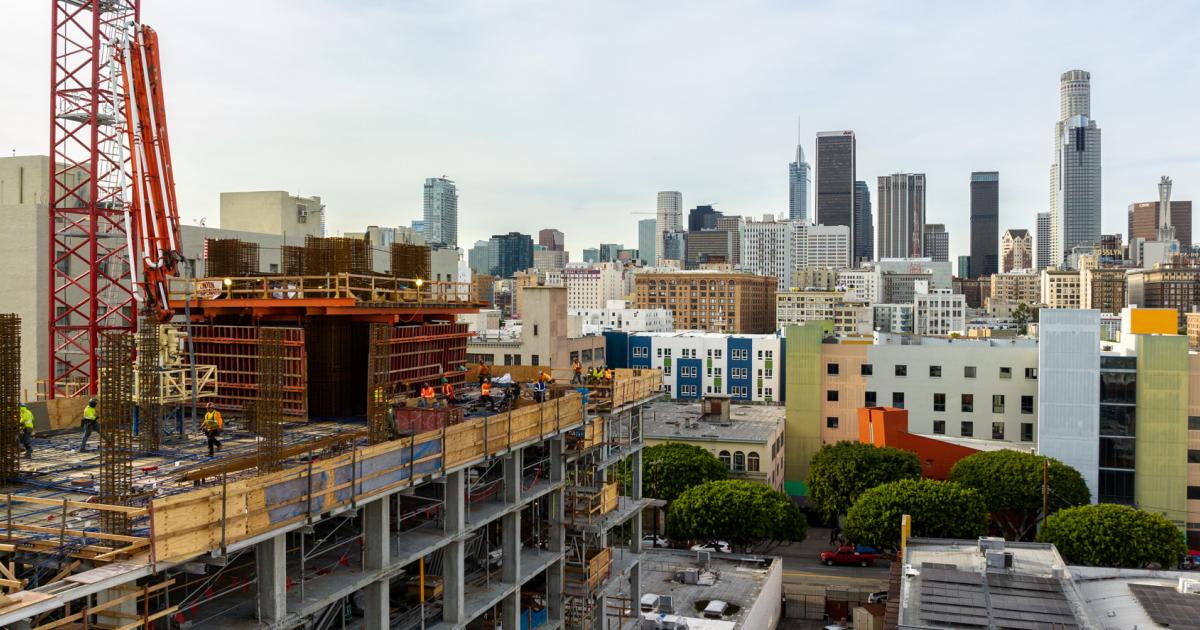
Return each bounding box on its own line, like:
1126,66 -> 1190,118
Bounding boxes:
221,191 -> 325,238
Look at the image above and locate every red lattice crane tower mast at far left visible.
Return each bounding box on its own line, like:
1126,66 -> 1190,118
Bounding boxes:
44,0 -> 140,397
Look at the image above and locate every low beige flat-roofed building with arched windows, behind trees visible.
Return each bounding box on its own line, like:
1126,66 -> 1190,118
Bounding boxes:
642,395 -> 787,492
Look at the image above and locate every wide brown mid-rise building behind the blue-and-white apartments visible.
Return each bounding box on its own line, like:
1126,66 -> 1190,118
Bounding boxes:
635,270 -> 775,334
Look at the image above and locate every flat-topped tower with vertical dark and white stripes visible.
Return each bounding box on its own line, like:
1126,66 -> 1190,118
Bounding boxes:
875,173 -> 925,258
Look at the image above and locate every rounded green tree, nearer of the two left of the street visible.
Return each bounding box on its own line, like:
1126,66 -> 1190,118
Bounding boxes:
667,479 -> 808,552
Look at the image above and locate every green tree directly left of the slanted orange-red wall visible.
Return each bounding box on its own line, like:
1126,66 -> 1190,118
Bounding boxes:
809,442 -> 920,518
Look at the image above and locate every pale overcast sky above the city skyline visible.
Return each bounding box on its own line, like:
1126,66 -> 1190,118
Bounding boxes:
0,0 -> 1200,259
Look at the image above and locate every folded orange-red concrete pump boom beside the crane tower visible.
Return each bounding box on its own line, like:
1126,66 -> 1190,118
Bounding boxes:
113,24 -> 184,320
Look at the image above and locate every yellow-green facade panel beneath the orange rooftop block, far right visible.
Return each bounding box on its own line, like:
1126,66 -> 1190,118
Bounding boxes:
1134,335 -> 1188,529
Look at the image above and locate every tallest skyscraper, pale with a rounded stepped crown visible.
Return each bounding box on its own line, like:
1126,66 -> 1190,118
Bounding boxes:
1049,70 -> 1100,266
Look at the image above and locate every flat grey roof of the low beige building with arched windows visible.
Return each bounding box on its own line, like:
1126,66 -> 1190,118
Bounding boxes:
642,401 -> 787,444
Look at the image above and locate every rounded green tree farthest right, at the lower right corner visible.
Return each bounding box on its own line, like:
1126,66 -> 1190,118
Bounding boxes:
1038,503 -> 1188,569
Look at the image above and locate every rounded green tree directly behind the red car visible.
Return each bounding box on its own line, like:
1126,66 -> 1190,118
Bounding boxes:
846,479 -> 988,548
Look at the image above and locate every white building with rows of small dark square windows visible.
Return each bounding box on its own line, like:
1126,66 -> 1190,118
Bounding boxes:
863,334 -> 1038,449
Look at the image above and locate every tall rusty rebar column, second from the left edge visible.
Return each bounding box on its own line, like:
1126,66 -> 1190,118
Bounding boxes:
98,331 -> 133,535
